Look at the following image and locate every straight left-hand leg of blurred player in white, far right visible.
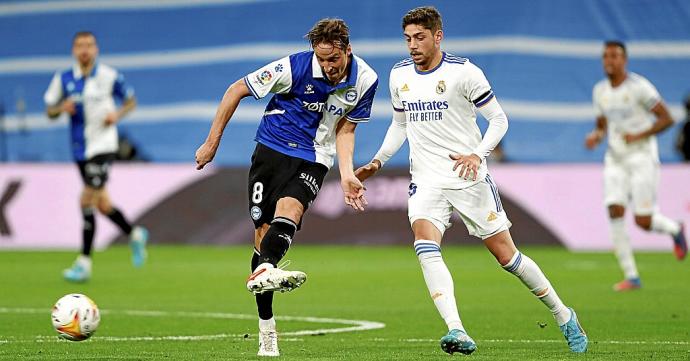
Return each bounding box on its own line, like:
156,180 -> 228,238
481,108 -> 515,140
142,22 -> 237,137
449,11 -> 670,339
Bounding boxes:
609,204 -> 642,291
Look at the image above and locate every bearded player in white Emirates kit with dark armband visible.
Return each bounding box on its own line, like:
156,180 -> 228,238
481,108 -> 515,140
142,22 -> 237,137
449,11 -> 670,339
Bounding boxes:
355,7 -> 587,354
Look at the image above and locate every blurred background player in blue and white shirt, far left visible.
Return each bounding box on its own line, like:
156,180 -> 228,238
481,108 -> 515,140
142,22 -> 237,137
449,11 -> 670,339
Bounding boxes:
44,31 -> 148,282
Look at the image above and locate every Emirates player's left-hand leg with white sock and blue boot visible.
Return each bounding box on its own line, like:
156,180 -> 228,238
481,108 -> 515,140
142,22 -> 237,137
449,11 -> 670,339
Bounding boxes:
412,219 -> 470,355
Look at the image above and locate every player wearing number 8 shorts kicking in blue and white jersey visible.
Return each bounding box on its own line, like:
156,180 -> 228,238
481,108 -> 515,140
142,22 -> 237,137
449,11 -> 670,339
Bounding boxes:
196,19 -> 378,356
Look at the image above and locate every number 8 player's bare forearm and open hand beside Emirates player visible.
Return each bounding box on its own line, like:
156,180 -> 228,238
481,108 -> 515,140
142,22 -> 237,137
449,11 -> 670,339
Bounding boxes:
335,118 -> 367,211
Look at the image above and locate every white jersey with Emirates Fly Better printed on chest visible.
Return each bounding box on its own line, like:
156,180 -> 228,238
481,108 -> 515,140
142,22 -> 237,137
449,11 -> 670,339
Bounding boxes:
390,53 -> 494,189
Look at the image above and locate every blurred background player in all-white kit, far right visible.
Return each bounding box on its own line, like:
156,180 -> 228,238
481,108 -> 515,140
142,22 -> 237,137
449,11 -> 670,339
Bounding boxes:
585,41 -> 688,291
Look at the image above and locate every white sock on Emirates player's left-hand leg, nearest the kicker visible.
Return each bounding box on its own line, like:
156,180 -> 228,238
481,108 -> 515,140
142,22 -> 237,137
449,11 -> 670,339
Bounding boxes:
414,240 -> 465,331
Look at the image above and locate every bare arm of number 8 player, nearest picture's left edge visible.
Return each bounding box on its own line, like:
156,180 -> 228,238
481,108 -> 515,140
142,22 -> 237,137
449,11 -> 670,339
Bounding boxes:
196,79 -> 251,169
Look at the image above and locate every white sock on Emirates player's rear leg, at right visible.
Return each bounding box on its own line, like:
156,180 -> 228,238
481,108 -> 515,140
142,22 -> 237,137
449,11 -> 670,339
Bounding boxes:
503,252 -> 570,326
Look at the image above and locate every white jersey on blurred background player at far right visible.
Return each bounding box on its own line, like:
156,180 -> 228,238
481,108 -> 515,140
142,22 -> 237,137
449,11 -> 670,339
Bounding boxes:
592,73 -> 661,160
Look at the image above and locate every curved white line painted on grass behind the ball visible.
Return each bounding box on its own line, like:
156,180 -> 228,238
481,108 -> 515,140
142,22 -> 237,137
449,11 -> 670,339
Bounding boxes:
0,307 -> 386,343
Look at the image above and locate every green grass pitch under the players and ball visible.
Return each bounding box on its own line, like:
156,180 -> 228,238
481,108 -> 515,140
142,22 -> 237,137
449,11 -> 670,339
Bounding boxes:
0,245 -> 690,361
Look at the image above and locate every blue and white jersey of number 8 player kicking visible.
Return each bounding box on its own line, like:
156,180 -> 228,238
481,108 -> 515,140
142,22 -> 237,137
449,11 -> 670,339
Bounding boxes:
244,51 -> 378,168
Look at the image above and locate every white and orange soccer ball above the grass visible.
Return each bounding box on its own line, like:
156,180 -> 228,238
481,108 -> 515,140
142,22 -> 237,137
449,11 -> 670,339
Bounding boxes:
50,293 -> 101,341
